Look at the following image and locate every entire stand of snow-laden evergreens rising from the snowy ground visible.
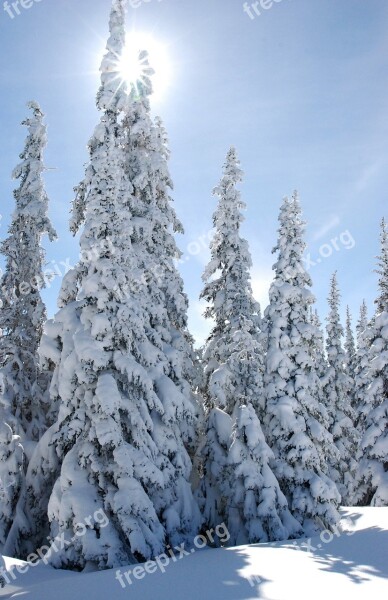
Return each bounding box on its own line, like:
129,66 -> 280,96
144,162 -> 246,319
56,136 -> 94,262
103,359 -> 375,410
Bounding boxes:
0,0 -> 388,569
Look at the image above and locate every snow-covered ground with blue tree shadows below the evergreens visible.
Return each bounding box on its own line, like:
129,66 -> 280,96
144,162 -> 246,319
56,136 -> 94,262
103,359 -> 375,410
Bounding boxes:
0,507 -> 388,600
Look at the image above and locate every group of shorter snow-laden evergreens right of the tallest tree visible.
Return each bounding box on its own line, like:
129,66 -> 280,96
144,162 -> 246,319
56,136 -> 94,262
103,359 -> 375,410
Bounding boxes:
197,156 -> 388,543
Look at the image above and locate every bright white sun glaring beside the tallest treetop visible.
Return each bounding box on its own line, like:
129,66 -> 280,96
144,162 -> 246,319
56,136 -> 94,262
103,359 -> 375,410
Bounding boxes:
120,32 -> 172,100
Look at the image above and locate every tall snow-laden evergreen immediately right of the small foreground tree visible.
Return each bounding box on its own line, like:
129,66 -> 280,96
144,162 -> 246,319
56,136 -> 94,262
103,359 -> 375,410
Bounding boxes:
265,192 -> 340,531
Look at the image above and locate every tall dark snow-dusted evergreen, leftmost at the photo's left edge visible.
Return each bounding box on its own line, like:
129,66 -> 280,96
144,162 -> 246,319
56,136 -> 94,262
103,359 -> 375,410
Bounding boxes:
0,102 -> 56,554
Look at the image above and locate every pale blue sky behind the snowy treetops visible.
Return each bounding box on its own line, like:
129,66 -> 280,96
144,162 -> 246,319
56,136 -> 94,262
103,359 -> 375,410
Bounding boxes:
0,0 -> 388,341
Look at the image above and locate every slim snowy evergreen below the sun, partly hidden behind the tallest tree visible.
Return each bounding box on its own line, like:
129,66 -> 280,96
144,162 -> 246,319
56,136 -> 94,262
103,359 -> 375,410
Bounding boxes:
124,79 -> 198,453
